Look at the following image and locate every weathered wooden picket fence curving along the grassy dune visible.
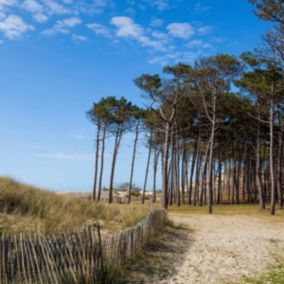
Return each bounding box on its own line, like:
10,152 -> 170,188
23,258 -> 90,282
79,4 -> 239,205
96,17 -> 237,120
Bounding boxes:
0,209 -> 165,284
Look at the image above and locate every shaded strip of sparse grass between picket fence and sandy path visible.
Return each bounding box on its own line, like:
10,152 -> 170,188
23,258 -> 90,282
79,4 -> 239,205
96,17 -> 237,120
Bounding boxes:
115,221 -> 191,284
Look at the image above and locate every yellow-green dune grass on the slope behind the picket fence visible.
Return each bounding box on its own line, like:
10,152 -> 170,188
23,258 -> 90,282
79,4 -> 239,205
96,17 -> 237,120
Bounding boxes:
0,177 -> 150,234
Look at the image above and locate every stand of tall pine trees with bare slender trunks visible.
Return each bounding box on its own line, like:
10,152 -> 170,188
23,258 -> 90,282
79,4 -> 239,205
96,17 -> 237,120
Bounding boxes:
87,0 -> 284,215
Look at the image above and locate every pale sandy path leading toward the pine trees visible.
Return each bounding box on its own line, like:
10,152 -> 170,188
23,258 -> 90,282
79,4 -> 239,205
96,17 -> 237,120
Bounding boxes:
159,215 -> 284,284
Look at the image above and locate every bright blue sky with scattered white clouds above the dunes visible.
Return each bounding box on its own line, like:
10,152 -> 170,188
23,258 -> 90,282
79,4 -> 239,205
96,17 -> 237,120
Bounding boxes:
0,0 -> 268,191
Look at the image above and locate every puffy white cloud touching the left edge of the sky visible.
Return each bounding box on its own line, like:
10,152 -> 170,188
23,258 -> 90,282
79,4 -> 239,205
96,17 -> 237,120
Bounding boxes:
0,15 -> 34,39
